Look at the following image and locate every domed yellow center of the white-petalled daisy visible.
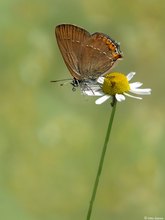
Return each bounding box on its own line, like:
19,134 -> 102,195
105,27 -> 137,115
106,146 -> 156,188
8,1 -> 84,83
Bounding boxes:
102,72 -> 130,95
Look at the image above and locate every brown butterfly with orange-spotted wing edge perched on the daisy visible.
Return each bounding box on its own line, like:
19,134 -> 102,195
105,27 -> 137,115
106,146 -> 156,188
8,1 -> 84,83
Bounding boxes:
52,24 -> 122,88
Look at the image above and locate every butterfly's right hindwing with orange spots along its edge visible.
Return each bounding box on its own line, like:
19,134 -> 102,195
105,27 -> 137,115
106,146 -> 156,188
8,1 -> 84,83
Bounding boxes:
79,33 -> 122,79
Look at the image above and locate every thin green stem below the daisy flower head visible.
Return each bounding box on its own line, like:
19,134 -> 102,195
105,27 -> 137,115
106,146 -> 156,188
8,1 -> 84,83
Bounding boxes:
86,99 -> 117,220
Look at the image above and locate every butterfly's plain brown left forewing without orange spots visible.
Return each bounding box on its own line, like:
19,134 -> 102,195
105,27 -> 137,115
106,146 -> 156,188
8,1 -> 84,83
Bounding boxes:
55,24 -> 90,80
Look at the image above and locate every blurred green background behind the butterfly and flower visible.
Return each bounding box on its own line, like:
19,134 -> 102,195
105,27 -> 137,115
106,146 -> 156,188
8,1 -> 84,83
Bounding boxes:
0,0 -> 165,220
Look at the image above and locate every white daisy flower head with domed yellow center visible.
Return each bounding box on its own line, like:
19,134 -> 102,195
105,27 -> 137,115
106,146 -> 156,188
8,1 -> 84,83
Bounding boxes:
83,72 -> 151,105
